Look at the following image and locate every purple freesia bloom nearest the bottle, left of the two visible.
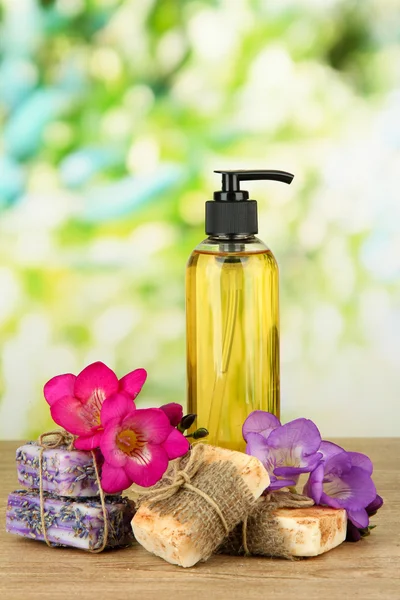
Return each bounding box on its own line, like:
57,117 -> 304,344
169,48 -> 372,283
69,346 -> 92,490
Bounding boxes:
243,410 -> 322,490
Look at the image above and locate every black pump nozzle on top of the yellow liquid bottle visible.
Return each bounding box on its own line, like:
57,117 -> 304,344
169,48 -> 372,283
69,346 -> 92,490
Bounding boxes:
206,170 -> 294,236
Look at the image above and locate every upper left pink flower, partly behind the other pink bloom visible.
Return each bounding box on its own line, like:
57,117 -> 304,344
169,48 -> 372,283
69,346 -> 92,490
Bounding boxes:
44,362 -> 147,450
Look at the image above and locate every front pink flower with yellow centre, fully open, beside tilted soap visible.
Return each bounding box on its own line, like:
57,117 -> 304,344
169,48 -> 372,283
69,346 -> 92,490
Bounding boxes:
100,394 -> 189,494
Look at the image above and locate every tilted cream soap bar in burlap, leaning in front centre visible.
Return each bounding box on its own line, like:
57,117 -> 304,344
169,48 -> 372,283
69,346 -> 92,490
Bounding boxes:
132,444 -> 269,567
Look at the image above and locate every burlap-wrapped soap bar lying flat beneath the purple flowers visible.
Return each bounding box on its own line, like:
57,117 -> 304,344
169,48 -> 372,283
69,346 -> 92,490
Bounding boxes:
218,491 -> 346,559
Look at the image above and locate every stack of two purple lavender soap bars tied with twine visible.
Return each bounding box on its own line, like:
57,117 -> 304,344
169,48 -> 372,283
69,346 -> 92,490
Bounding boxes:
6,442 -> 135,550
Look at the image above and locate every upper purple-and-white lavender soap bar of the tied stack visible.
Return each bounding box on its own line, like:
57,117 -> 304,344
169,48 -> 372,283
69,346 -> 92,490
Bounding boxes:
16,442 -> 100,497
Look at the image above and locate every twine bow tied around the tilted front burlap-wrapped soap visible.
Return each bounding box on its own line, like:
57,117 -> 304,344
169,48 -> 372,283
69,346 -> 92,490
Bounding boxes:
139,444 -> 230,535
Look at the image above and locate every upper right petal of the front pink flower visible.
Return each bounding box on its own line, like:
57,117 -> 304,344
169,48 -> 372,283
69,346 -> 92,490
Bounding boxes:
122,408 -> 171,444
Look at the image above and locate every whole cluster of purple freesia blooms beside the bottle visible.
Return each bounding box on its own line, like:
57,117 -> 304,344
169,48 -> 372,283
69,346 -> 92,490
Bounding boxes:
243,410 -> 383,541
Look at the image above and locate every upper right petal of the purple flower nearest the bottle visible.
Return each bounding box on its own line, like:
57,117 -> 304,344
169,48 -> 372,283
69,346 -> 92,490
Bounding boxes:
268,419 -> 321,458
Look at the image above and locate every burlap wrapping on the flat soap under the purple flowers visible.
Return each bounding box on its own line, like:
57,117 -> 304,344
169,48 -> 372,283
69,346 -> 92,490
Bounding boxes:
218,492 -> 314,560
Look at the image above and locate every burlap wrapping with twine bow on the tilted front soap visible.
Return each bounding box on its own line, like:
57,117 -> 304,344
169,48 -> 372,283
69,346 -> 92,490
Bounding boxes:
136,444 -> 257,560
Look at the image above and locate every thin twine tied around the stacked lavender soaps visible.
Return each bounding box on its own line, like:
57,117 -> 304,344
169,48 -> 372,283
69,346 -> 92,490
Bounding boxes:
38,429 -> 108,554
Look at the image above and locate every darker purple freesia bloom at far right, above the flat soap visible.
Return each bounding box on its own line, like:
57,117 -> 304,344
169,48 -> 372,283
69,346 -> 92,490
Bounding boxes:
303,441 -> 376,529
